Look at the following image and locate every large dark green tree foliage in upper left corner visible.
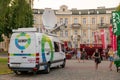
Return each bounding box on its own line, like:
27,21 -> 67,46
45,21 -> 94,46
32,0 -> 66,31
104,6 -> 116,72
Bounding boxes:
0,0 -> 33,41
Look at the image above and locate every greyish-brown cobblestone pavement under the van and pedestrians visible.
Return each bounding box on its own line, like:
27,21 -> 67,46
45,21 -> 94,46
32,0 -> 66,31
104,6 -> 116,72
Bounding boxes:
0,60 -> 120,80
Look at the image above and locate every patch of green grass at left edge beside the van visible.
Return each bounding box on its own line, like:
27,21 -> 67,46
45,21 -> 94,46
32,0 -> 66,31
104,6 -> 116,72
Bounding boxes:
0,58 -> 12,74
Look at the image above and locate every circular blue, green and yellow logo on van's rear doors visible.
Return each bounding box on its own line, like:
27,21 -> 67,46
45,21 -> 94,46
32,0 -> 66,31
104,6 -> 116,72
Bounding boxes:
15,33 -> 31,50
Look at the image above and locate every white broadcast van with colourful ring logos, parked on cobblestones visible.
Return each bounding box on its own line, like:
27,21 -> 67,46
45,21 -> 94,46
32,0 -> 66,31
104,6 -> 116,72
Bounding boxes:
8,28 -> 66,74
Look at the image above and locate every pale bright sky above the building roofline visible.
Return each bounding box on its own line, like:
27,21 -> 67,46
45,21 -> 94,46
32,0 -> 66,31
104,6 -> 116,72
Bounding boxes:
33,0 -> 120,9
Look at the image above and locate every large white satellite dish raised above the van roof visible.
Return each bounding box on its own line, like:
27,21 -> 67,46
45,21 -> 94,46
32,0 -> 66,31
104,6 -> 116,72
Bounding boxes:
42,8 -> 57,29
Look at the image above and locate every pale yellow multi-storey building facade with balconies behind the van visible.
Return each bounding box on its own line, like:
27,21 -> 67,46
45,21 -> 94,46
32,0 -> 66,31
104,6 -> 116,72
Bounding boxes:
33,5 -> 115,48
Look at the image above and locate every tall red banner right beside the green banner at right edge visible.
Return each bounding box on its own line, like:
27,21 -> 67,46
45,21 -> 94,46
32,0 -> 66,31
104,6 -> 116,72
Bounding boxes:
109,26 -> 117,51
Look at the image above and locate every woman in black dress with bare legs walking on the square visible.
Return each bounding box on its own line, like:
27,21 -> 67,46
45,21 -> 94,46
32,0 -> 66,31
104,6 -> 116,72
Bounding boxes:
92,49 -> 101,70
